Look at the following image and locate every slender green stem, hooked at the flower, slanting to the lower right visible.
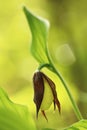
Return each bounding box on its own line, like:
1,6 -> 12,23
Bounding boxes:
38,60 -> 83,120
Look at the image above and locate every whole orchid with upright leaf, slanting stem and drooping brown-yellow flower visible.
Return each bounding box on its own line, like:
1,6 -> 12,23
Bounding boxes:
23,7 -> 87,130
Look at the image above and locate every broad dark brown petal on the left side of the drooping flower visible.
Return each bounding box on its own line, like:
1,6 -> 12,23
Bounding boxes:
33,71 -> 44,117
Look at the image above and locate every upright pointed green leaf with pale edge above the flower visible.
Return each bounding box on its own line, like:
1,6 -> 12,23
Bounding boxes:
23,7 -> 49,63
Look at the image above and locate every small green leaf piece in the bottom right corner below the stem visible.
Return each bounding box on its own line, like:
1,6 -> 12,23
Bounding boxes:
64,120 -> 87,130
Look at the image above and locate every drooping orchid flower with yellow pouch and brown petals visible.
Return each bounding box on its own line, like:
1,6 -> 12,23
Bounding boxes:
33,71 -> 61,120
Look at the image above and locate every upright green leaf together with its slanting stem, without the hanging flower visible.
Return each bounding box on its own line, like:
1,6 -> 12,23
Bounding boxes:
24,7 -> 82,120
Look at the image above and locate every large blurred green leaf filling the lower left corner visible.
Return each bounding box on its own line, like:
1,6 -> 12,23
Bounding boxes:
0,88 -> 36,130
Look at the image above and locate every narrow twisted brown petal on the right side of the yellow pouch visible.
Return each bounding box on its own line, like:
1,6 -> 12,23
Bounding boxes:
41,72 -> 61,113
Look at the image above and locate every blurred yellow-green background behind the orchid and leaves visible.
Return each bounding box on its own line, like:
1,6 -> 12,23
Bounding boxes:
0,0 -> 87,129
